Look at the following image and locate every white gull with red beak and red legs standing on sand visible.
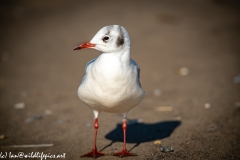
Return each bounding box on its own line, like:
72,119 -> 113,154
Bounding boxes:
74,25 -> 145,157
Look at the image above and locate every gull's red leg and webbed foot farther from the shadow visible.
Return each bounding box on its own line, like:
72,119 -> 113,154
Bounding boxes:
81,118 -> 104,158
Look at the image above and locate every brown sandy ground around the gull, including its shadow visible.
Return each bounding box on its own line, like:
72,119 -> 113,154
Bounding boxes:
0,0 -> 240,160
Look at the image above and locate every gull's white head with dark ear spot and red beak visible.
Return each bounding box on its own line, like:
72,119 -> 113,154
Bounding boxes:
74,25 -> 130,53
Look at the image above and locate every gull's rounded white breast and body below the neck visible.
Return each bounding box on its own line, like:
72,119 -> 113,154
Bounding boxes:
78,53 -> 145,113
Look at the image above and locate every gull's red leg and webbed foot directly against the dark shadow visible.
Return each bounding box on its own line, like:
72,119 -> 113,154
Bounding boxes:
114,119 -> 136,157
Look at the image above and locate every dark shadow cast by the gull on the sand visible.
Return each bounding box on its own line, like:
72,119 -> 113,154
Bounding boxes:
101,120 -> 181,151
